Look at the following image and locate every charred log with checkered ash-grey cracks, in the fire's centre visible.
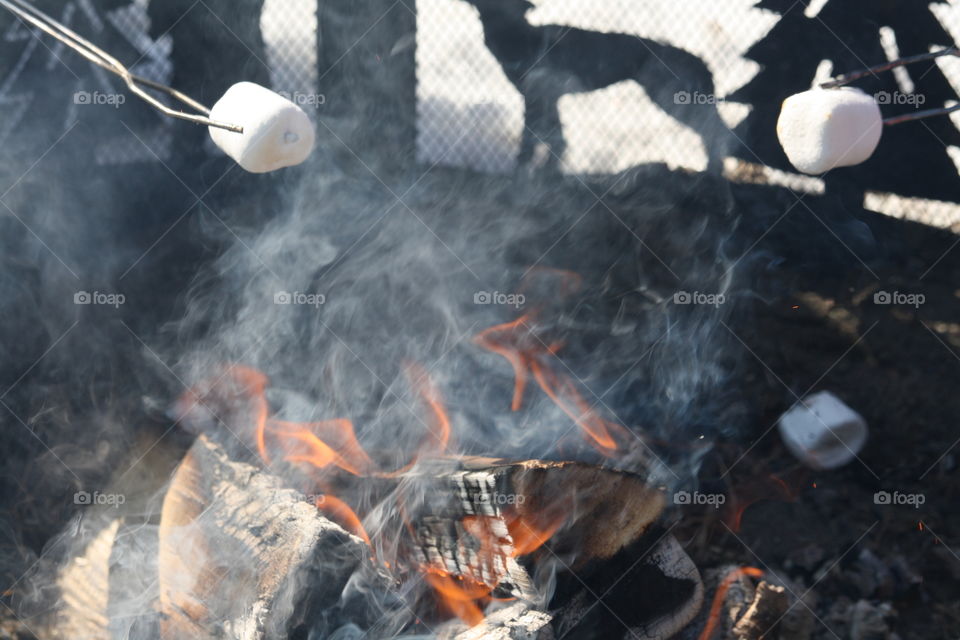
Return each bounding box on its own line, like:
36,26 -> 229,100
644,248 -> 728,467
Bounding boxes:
404,458 -> 664,601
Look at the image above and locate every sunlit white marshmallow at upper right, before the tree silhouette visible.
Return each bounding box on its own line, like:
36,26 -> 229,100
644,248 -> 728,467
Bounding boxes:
777,87 -> 883,174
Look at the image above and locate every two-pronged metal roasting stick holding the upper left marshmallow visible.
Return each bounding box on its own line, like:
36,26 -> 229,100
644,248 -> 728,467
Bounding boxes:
0,0 -> 243,133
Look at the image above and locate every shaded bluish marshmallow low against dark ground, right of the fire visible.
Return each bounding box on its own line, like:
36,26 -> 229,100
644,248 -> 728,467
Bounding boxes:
777,391 -> 867,469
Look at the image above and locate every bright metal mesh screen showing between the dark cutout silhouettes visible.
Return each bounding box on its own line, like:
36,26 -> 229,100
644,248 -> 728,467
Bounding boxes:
0,0 -> 960,189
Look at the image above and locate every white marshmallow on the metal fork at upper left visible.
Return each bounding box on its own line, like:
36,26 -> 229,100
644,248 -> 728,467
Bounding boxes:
209,82 -> 314,173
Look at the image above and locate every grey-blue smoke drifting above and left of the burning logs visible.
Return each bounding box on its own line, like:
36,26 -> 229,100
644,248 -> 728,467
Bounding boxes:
0,2 -> 750,638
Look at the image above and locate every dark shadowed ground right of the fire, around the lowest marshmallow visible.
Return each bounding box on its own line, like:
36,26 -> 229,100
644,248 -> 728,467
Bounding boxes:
679,176 -> 960,640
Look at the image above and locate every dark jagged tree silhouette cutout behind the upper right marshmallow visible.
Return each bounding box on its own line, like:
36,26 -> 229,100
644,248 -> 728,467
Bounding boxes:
730,0 -> 960,201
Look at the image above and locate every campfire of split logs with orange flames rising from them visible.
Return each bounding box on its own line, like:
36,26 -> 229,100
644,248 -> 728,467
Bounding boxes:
80,270 -> 703,639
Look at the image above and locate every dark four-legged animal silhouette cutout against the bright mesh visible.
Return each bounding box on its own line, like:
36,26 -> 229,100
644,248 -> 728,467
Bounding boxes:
466,0 -> 730,172
